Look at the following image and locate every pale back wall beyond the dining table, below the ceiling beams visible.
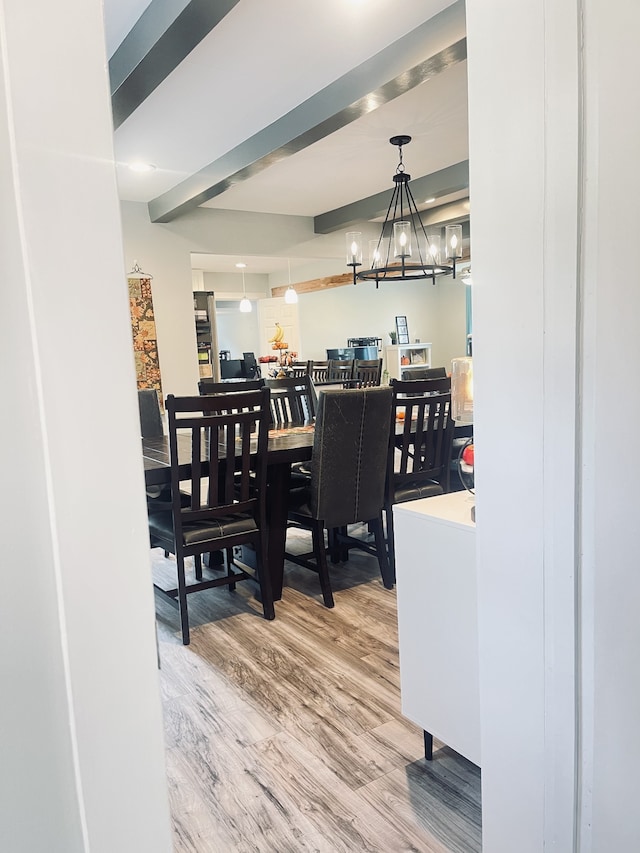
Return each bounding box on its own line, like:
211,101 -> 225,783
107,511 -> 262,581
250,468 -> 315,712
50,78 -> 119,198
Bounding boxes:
122,202 -> 466,384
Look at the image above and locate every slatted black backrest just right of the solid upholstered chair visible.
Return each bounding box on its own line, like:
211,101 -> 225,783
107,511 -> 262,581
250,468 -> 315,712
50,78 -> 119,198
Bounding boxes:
388,377 -> 455,492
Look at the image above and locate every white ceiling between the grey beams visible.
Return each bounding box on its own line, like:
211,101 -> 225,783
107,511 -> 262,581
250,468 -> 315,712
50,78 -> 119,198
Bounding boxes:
104,0 -> 468,272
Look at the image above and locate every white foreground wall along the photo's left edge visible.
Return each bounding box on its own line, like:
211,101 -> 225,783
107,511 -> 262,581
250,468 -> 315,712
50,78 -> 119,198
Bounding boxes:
0,0 -> 172,853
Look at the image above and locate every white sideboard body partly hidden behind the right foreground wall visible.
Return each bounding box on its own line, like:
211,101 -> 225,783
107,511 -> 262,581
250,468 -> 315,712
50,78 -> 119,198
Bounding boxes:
393,492 -> 480,765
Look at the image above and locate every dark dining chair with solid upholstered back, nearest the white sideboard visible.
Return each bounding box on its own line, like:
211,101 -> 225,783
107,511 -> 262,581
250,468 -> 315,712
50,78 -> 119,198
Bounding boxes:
286,387 -> 393,607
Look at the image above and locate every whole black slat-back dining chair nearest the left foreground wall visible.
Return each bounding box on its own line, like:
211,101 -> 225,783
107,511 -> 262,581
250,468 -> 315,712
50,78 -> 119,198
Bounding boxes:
149,388 -> 275,645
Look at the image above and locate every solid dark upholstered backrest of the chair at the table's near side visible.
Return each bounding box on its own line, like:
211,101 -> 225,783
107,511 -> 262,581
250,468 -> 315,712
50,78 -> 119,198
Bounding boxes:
310,386 -> 392,528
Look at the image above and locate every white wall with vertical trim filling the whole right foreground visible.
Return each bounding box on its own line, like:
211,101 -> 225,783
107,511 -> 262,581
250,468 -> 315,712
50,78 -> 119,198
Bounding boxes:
467,0 -> 640,853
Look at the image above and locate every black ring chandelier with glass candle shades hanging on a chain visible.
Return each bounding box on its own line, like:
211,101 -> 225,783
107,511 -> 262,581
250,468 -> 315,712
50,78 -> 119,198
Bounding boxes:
347,134 -> 462,287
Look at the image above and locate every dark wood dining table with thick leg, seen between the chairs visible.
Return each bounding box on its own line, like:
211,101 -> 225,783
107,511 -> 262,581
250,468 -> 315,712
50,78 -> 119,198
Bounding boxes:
142,425 -> 313,601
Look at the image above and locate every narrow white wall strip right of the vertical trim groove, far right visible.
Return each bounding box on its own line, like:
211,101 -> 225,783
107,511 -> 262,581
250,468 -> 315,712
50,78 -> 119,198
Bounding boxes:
580,5 -> 640,853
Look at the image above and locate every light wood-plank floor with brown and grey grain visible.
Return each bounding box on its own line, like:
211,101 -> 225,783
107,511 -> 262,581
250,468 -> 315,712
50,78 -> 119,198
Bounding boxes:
152,533 -> 482,853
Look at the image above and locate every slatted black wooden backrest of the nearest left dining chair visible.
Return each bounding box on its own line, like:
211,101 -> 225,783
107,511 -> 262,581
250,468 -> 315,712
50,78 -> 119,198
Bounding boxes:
166,388 -> 269,536
